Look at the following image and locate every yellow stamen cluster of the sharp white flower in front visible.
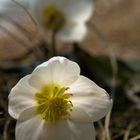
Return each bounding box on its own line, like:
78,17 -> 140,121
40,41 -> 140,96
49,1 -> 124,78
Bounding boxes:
35,84 -> 73,123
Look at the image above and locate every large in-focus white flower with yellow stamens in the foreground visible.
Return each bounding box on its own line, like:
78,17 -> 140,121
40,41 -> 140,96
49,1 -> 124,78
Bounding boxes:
9,57 -> 111,140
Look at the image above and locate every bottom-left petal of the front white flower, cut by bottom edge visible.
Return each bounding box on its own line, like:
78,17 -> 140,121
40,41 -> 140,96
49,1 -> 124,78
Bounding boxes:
16,108 -> 46,140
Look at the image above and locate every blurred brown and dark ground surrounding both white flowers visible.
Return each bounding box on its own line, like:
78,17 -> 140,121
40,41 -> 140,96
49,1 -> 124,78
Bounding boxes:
0,0 -> 140,140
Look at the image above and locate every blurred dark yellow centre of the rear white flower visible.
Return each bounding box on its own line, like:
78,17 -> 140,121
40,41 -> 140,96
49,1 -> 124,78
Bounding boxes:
43,5 -> 65,31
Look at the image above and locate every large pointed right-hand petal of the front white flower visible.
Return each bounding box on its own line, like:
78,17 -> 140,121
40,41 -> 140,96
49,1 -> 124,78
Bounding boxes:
69,76 -> 112,122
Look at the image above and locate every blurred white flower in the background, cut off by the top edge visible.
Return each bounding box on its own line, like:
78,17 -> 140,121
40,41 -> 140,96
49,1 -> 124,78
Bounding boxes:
30,0 -> 94,42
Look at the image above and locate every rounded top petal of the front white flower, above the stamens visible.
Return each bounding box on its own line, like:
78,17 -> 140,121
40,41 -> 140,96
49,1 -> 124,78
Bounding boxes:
29,57 -> 80,88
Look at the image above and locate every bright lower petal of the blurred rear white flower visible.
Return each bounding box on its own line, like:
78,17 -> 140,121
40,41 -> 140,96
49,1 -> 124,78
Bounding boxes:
58,23 -> 87,42
